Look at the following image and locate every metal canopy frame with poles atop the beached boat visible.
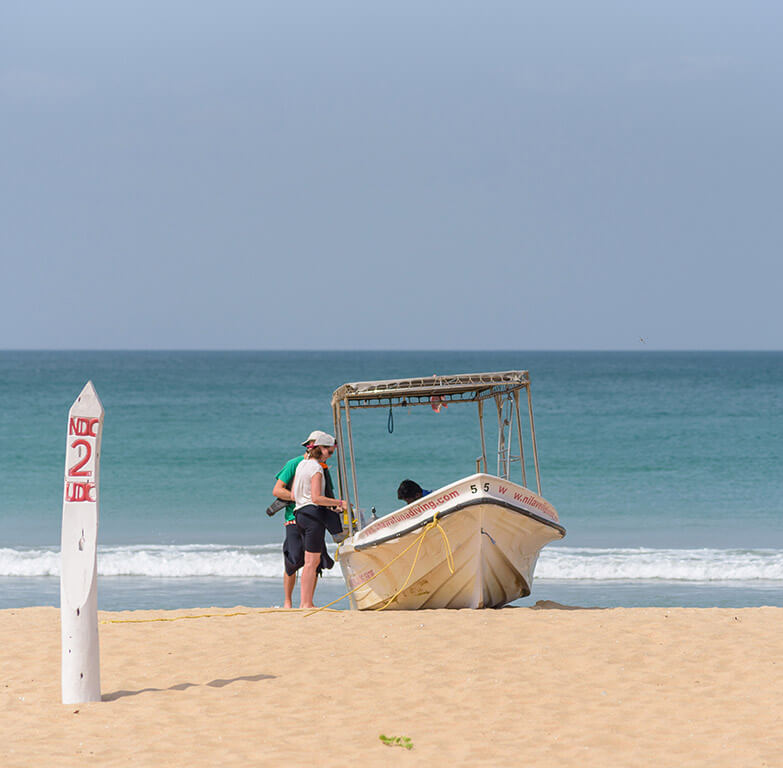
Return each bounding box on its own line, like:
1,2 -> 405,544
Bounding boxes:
332,371 -> 541,536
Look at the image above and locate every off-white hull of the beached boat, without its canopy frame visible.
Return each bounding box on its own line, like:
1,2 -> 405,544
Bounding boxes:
339,474 -> 565,610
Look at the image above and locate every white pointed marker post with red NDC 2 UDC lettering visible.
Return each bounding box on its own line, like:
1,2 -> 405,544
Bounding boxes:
60,381 -> 103,704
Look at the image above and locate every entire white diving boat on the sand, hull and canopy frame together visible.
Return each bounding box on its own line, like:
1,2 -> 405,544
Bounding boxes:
332,371 -> 565,610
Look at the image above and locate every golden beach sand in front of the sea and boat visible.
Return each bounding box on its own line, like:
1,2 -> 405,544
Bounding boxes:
0,603 -> 783,768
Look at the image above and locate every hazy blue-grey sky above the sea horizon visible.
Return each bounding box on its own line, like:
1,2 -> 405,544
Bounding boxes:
0,0 -> 783,350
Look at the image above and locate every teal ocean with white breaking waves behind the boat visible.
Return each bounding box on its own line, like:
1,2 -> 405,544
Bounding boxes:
0,348 -> 783,610
